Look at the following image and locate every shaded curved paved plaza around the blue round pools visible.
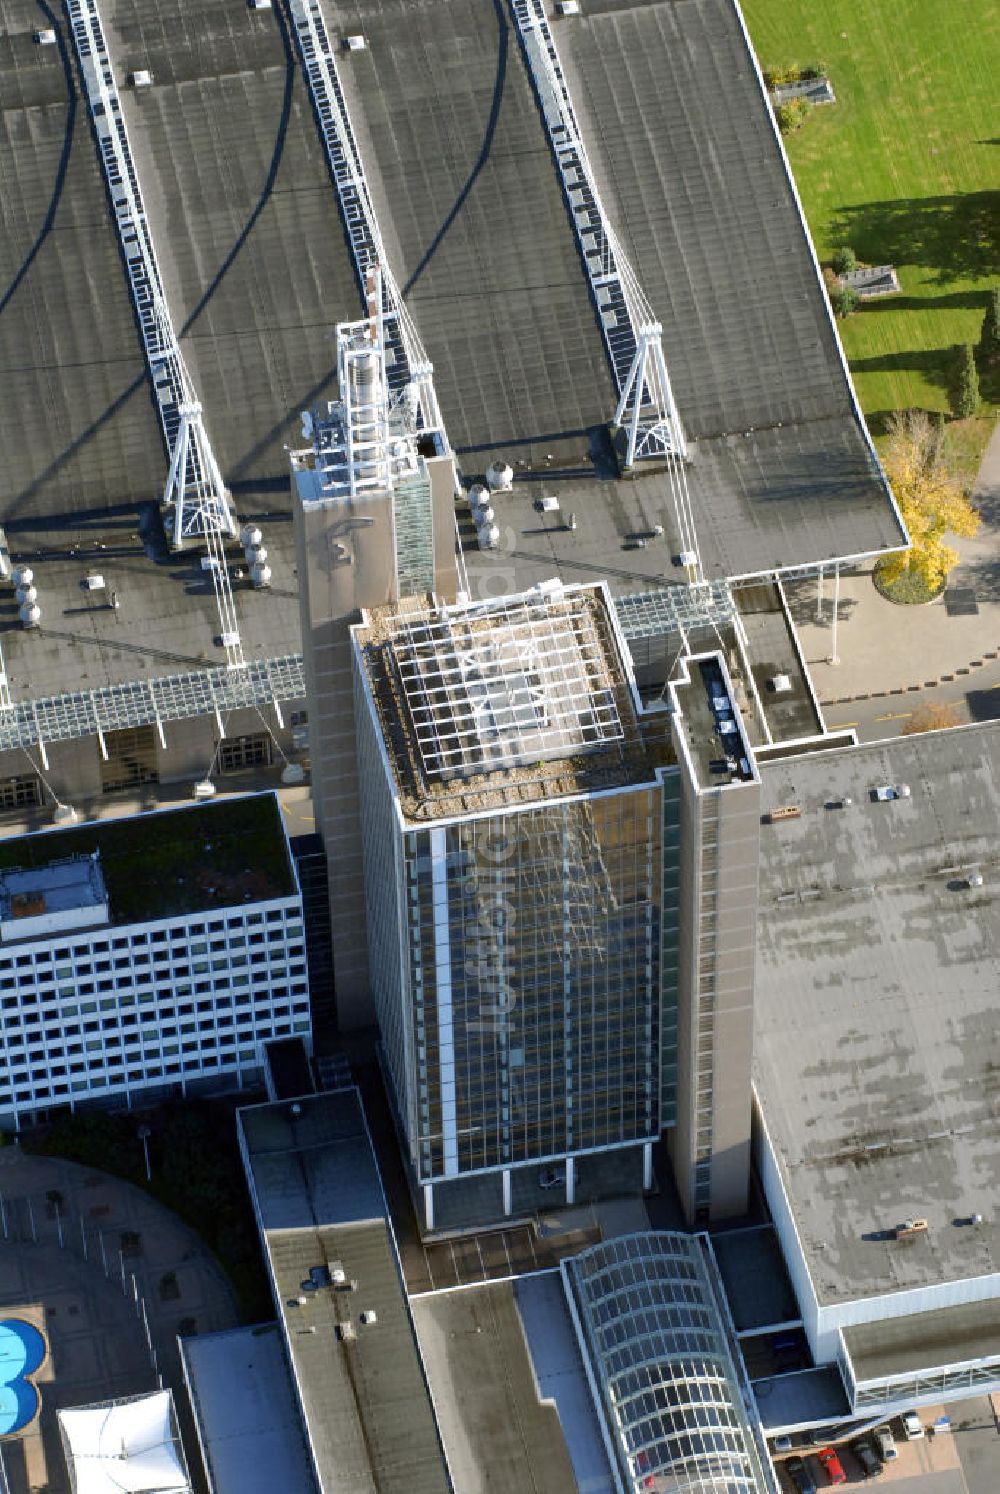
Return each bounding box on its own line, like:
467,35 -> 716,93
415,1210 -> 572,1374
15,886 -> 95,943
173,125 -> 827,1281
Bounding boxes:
0,1146 -> 239,1494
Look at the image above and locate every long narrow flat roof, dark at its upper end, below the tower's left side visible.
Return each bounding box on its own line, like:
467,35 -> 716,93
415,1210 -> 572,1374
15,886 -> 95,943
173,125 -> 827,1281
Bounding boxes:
239,1089 -> 451,1494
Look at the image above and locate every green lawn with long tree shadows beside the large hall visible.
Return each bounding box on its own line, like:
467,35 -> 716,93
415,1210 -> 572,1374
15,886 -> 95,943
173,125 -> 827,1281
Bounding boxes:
743,0 -> 1000,444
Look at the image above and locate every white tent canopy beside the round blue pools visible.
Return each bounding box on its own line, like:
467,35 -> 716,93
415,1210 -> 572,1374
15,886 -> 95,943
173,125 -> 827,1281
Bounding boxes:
58,1391 -> 191,1494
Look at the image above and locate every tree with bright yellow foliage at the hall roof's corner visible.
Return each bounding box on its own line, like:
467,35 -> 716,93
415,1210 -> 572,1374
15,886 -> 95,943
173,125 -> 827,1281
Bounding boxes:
877,409 -> 979,596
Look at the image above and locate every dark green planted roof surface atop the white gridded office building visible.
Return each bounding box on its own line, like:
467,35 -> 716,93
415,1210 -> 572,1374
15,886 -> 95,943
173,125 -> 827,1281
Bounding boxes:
0,793 -> 294,923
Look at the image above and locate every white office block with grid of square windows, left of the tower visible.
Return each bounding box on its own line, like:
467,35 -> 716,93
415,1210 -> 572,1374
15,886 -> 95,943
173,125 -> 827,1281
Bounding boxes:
0,793 -> 311,1128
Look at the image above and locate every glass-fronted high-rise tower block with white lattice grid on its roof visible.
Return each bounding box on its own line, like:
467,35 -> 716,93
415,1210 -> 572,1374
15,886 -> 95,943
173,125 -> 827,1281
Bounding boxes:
353,584 -> 679,1219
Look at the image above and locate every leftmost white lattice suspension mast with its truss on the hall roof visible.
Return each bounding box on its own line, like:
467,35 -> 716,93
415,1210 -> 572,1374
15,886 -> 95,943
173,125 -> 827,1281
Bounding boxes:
66,0 -> 245,668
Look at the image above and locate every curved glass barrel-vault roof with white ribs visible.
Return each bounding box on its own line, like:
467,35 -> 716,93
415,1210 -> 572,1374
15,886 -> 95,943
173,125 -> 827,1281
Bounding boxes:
562,1234 -> 771,1494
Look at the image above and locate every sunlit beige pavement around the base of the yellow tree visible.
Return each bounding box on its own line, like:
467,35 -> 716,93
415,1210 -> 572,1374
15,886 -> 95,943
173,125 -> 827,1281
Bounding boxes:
789,424 -> 1000,735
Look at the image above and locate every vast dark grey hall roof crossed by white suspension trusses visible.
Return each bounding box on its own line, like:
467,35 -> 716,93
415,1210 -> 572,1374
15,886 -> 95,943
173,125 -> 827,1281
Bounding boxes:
0,0 -> 898,711
